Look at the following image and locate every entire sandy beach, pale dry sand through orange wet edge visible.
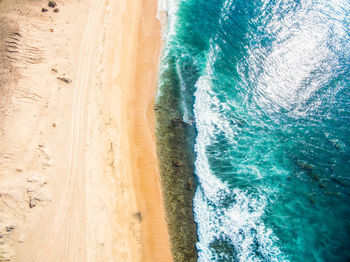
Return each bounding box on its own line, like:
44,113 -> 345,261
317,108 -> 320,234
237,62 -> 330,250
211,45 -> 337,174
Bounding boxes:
0,0 -> 172,262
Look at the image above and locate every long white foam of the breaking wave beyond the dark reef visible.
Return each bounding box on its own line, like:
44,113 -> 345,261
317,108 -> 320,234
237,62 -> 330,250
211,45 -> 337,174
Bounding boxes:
194,0 -> 286,262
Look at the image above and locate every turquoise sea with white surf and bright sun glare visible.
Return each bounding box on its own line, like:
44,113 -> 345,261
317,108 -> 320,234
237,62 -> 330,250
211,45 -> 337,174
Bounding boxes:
161,0 -> 350,262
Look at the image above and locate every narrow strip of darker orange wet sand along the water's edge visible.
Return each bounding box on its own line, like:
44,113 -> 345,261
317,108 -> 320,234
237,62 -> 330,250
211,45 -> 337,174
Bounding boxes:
133,0 -> 172,262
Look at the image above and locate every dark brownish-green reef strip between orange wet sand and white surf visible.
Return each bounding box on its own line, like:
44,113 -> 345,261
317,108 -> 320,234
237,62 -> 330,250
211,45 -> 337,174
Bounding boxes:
155,54 -> 197,262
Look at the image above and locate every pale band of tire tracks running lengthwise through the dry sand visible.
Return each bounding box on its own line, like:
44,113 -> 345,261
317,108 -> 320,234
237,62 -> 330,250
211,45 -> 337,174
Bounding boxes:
38,0 -> 106,262
